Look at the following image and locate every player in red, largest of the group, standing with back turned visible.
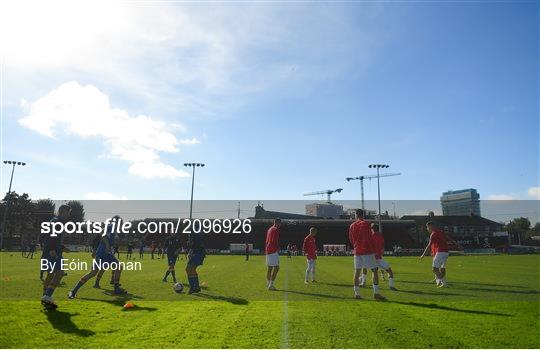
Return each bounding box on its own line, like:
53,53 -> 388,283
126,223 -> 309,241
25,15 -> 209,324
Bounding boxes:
349,209 -> 386,300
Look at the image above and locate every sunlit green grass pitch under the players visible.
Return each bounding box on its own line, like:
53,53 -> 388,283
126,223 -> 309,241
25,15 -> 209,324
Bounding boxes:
0,253 -> 540,348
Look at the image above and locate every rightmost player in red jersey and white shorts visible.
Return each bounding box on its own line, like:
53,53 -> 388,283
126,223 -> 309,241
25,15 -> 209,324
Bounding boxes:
420,221 -> 448,287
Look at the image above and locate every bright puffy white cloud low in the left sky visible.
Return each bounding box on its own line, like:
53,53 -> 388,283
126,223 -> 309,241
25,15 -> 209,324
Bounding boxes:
19,81 -> 192,178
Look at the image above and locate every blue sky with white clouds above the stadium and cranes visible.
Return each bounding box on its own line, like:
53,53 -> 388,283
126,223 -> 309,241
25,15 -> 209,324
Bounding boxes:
0,1 -> 540,205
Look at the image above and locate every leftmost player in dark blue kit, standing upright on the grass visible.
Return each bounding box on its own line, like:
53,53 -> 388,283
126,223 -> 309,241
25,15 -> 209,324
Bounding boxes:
40,204 -> 71,309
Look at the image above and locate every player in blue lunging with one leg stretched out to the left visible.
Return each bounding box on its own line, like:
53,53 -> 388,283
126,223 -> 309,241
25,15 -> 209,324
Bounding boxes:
68,216 -> 127,299
